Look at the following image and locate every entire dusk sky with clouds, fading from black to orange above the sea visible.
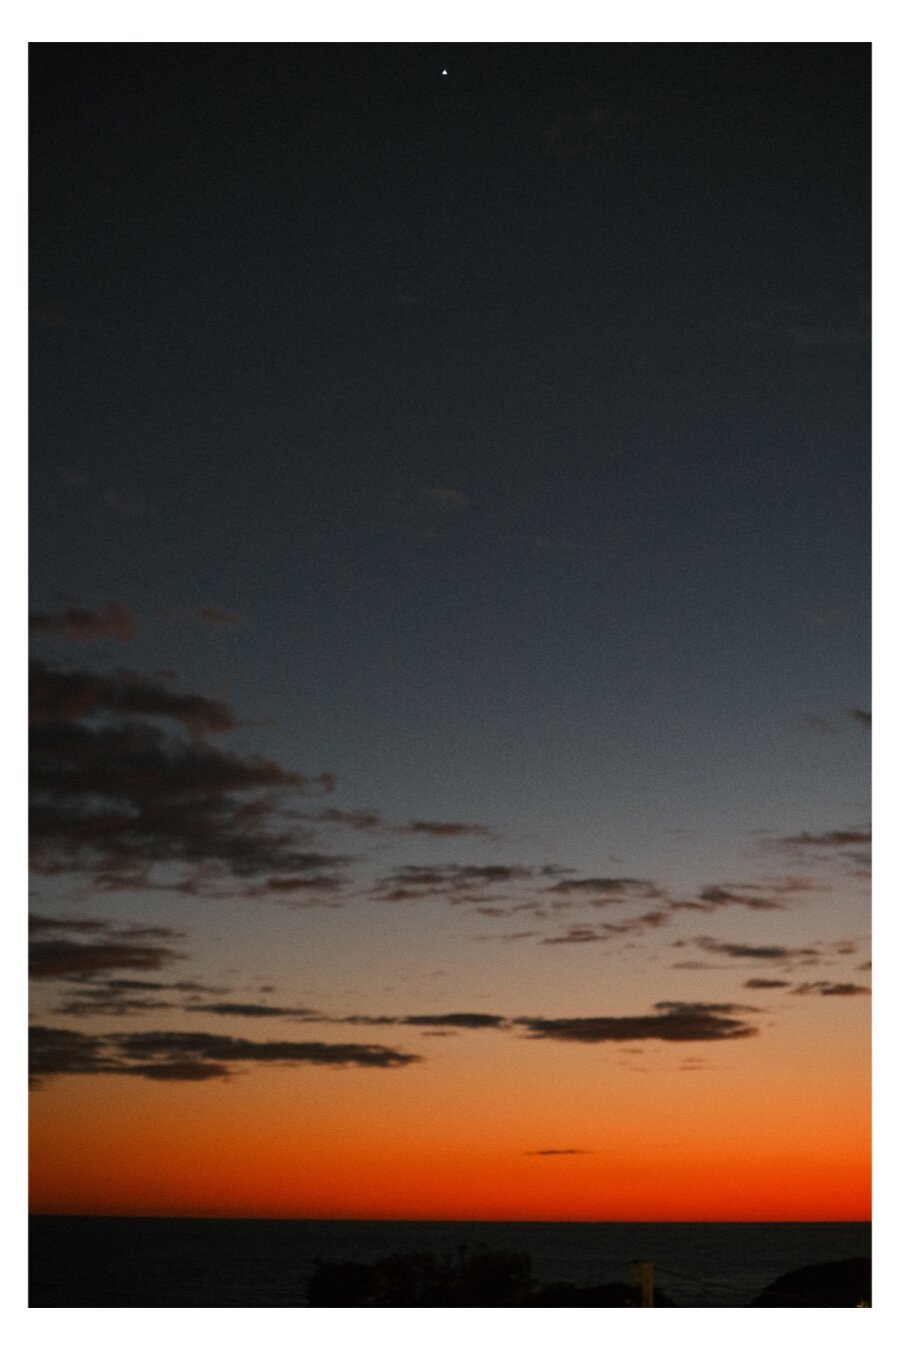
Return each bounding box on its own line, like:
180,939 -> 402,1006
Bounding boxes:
30,42 -> 872,1220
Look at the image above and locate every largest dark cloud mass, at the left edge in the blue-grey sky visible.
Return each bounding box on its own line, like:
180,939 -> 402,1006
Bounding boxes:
31,664 -> 344,894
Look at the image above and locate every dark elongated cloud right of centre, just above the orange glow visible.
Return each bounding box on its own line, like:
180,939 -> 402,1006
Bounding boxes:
515,1003 -> 757,1045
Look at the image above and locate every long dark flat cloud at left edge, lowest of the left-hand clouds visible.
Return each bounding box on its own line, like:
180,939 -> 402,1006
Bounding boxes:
30,1026 -> 421,1087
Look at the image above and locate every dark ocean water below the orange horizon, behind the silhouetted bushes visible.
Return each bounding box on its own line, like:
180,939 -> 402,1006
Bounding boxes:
28,1215 -> 872,1308
